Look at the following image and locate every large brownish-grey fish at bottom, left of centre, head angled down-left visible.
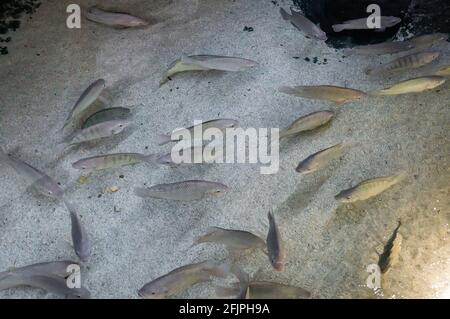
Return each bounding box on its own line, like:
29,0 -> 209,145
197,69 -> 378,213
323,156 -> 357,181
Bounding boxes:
138,261 -> 230,299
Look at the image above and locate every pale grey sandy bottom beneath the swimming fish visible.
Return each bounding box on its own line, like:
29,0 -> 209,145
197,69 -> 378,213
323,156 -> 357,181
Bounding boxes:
0,0 -> 450,298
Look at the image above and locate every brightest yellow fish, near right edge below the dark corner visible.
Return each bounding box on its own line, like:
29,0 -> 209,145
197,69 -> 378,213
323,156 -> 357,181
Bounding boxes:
371,75 -> 445,96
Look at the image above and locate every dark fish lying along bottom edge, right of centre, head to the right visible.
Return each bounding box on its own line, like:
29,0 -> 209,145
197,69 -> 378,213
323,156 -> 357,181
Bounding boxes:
216,281 -> 311,299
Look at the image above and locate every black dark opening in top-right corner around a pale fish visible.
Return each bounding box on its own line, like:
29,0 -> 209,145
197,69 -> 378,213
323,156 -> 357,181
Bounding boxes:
293,0 -> 450,48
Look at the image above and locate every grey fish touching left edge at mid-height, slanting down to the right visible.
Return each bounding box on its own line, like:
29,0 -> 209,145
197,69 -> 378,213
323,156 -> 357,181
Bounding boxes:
0,150 -> 64,199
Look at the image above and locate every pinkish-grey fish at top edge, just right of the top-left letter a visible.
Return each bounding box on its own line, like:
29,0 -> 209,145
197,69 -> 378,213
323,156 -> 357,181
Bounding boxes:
86,7 -> 149,28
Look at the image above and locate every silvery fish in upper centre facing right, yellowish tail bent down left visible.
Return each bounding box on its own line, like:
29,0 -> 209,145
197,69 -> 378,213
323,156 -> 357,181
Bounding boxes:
159,55 -> 258,86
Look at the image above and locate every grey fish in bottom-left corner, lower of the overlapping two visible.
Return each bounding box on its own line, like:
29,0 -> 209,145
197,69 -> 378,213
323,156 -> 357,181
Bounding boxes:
0,272 -> 91,299
